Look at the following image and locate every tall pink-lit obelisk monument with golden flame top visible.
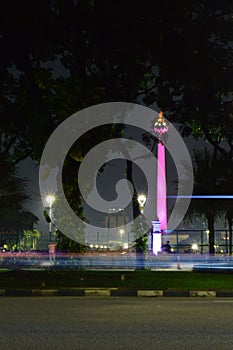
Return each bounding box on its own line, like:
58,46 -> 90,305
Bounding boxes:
154,112 -> 168,231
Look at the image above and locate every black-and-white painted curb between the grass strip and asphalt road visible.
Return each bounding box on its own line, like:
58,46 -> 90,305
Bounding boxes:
0,288 -> 233,298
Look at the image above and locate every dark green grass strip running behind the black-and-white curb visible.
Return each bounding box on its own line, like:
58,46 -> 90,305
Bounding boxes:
0,270 -> 233,290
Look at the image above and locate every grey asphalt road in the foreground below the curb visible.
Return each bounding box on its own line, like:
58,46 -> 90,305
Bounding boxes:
0,297 -> 233,350
